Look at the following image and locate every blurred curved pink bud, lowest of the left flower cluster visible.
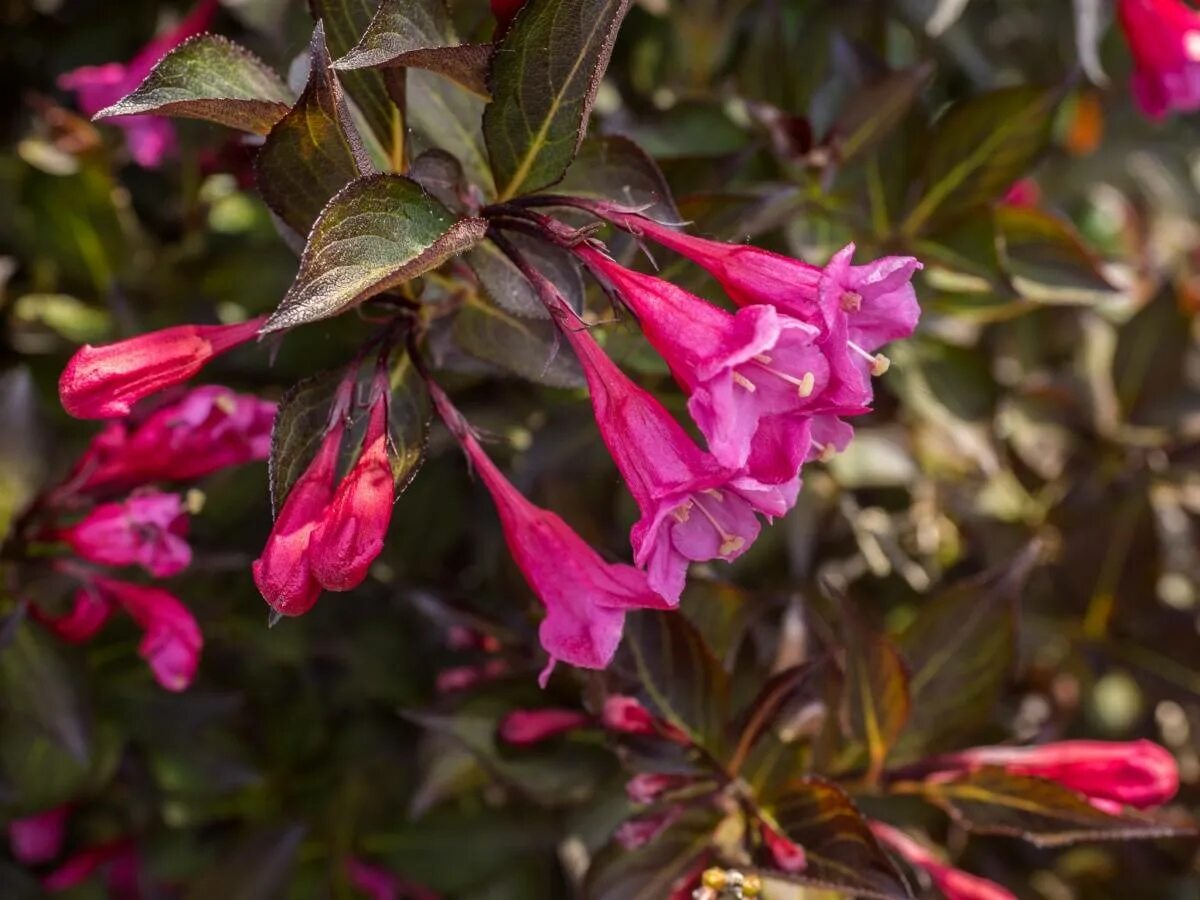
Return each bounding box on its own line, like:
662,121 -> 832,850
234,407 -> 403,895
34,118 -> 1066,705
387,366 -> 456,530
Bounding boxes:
94,578 -> 204,691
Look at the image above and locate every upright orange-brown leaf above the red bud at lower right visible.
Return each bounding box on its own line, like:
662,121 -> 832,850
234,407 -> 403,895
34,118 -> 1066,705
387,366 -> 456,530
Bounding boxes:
842,606 -> 912,775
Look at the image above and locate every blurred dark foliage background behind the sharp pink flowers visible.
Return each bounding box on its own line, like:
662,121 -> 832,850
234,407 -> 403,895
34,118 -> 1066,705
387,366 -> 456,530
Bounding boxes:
0,0 -> 1200,900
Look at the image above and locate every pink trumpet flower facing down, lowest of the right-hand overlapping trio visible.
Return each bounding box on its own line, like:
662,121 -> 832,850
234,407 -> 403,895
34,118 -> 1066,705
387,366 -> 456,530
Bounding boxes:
559,297 -> 768,602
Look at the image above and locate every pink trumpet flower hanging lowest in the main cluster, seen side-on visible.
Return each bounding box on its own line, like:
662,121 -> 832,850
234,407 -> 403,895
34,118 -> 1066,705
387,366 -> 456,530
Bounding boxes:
430,384 -> 667,685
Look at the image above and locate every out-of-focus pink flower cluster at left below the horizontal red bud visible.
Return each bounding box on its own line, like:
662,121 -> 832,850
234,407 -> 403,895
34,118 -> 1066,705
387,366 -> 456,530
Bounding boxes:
28,386 -> 275,691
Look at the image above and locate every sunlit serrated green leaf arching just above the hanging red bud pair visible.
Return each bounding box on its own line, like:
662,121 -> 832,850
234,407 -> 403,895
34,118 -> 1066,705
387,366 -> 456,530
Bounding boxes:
263,174 -> 487,332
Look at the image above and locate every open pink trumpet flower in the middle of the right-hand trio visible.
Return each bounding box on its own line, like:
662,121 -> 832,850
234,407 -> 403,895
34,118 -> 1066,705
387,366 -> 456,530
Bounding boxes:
576,245 -> 840,472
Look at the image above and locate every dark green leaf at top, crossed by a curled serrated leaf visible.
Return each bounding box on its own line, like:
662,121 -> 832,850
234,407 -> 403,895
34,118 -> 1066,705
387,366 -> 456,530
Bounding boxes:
308,0 -> 404,168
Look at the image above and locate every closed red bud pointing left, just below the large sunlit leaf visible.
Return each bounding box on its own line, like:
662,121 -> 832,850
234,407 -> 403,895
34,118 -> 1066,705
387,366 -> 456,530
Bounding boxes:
59,317 -> 265,419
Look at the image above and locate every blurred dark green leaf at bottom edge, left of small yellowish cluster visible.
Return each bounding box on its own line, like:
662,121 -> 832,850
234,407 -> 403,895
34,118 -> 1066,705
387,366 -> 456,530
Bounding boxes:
583,808 -> 719,900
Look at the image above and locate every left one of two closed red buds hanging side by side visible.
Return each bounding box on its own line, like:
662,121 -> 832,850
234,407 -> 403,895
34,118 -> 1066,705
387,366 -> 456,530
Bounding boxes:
251,378 -> 354,616
